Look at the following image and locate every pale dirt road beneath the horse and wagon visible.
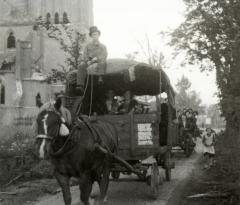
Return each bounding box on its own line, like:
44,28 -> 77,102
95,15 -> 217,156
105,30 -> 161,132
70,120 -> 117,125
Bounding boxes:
35,151 -> 200,205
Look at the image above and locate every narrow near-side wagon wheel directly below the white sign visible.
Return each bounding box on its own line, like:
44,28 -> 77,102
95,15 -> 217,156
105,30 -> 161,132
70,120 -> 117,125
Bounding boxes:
150,163 -> 161,199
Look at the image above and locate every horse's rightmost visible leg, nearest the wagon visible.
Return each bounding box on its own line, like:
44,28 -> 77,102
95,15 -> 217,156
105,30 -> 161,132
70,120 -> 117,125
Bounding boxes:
98,159 -> 110,203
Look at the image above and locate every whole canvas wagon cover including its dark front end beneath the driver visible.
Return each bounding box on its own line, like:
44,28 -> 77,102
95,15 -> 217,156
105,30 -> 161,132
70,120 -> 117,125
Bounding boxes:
72,59 -> 175,113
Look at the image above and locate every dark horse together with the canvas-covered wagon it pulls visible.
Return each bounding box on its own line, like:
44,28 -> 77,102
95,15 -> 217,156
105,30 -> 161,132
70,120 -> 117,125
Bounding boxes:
36,60 -> 176,205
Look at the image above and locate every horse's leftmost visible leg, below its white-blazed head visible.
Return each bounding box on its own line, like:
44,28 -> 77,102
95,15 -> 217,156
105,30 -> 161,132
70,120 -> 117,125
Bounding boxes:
54,172 -> 72,205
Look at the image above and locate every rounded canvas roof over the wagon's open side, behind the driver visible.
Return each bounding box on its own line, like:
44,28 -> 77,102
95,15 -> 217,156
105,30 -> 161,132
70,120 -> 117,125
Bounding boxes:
97,59 -> 171,95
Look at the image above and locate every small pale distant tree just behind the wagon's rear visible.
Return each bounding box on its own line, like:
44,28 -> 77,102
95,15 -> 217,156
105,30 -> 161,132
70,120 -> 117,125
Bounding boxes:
176,76 -> 201,110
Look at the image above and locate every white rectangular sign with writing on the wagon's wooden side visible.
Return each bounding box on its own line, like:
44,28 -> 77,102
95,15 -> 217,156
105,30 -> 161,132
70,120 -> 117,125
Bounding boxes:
137,123 -> 153,145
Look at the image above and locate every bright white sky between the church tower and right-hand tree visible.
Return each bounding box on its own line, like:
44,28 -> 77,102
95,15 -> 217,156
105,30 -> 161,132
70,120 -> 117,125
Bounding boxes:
94,0 -> 218,105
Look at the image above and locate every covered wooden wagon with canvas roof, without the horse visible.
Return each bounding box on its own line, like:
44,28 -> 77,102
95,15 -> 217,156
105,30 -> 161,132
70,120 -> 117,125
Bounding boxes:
66,59 -> 176,197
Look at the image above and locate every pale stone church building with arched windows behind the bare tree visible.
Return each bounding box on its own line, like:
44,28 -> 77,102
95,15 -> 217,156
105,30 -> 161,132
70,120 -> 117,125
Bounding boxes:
0,0 -> 93,128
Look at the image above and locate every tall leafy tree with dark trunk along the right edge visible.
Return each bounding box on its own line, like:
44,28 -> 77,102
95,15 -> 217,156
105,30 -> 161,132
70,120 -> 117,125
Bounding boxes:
171,0 -> 240,192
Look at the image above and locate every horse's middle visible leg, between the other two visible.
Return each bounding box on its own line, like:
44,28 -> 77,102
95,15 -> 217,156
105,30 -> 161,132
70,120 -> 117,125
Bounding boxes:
79,173 -> 93,205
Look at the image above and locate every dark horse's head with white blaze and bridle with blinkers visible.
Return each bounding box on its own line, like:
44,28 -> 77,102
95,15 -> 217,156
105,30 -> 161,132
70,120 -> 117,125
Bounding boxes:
36,100 -> 69,159
